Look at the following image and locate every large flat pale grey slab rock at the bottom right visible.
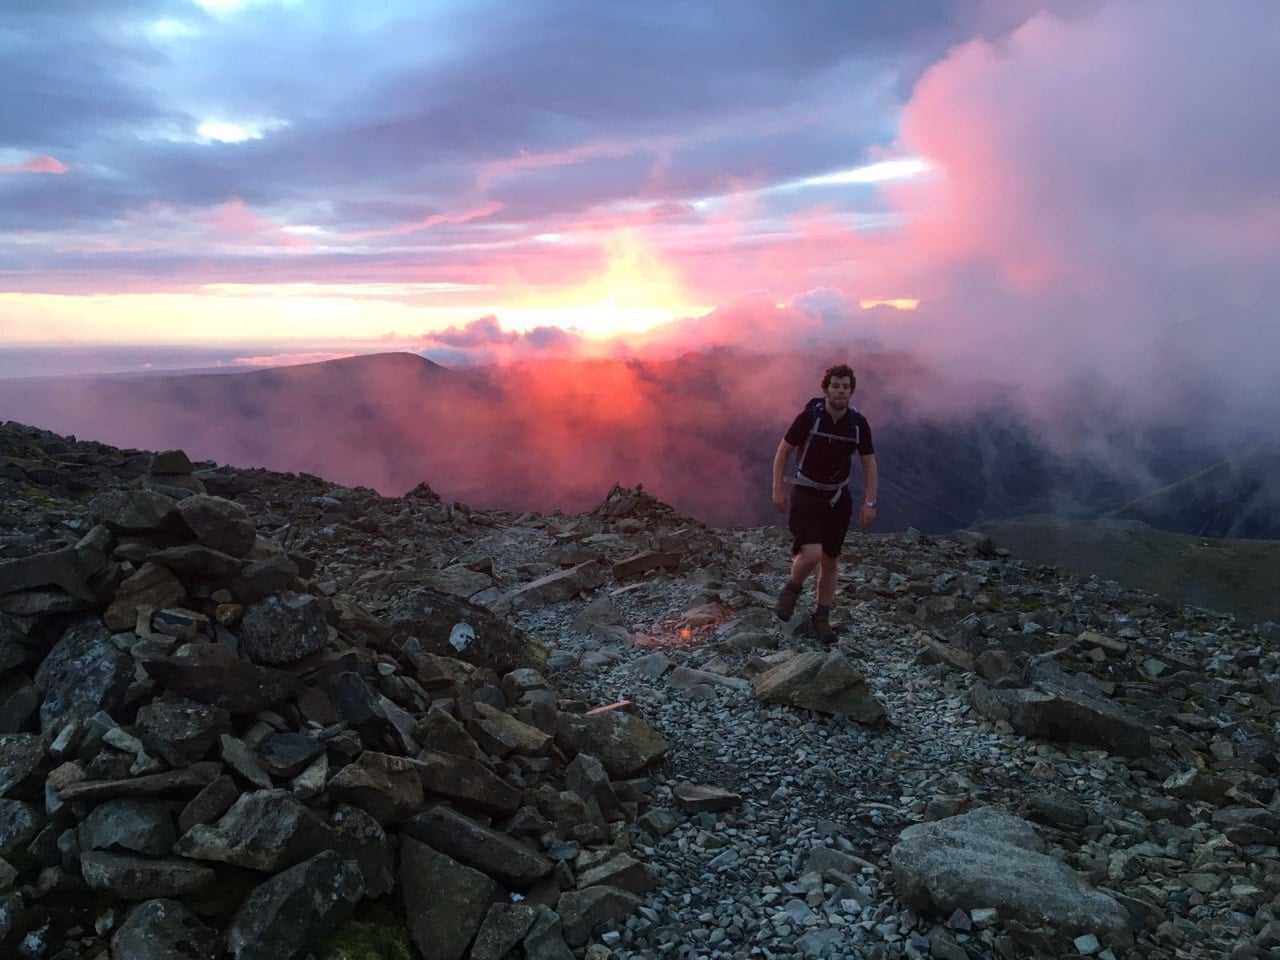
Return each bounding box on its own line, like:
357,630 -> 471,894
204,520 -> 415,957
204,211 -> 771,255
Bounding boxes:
890,806 -> 1129,934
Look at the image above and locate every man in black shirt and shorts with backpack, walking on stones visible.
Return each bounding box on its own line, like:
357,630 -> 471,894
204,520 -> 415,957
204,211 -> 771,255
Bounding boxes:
773,364 -> 879,646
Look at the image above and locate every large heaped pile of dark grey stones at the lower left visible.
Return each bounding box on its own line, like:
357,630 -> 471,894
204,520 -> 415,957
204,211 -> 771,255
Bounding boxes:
0,437 -> 667,960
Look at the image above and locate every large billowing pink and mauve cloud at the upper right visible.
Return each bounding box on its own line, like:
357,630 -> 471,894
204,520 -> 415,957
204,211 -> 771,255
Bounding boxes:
854,0 -> 1280,435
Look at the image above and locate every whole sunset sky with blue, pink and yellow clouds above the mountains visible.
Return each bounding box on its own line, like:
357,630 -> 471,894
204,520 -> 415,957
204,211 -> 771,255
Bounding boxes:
0,0 -> 1280,442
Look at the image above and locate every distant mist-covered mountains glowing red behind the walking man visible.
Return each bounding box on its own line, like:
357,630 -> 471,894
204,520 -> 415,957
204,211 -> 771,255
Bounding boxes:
0,349 -> 1259,536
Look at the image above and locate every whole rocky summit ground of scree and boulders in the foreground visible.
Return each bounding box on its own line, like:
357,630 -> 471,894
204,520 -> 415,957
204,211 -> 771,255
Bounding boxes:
0,424 -> 1280,960
